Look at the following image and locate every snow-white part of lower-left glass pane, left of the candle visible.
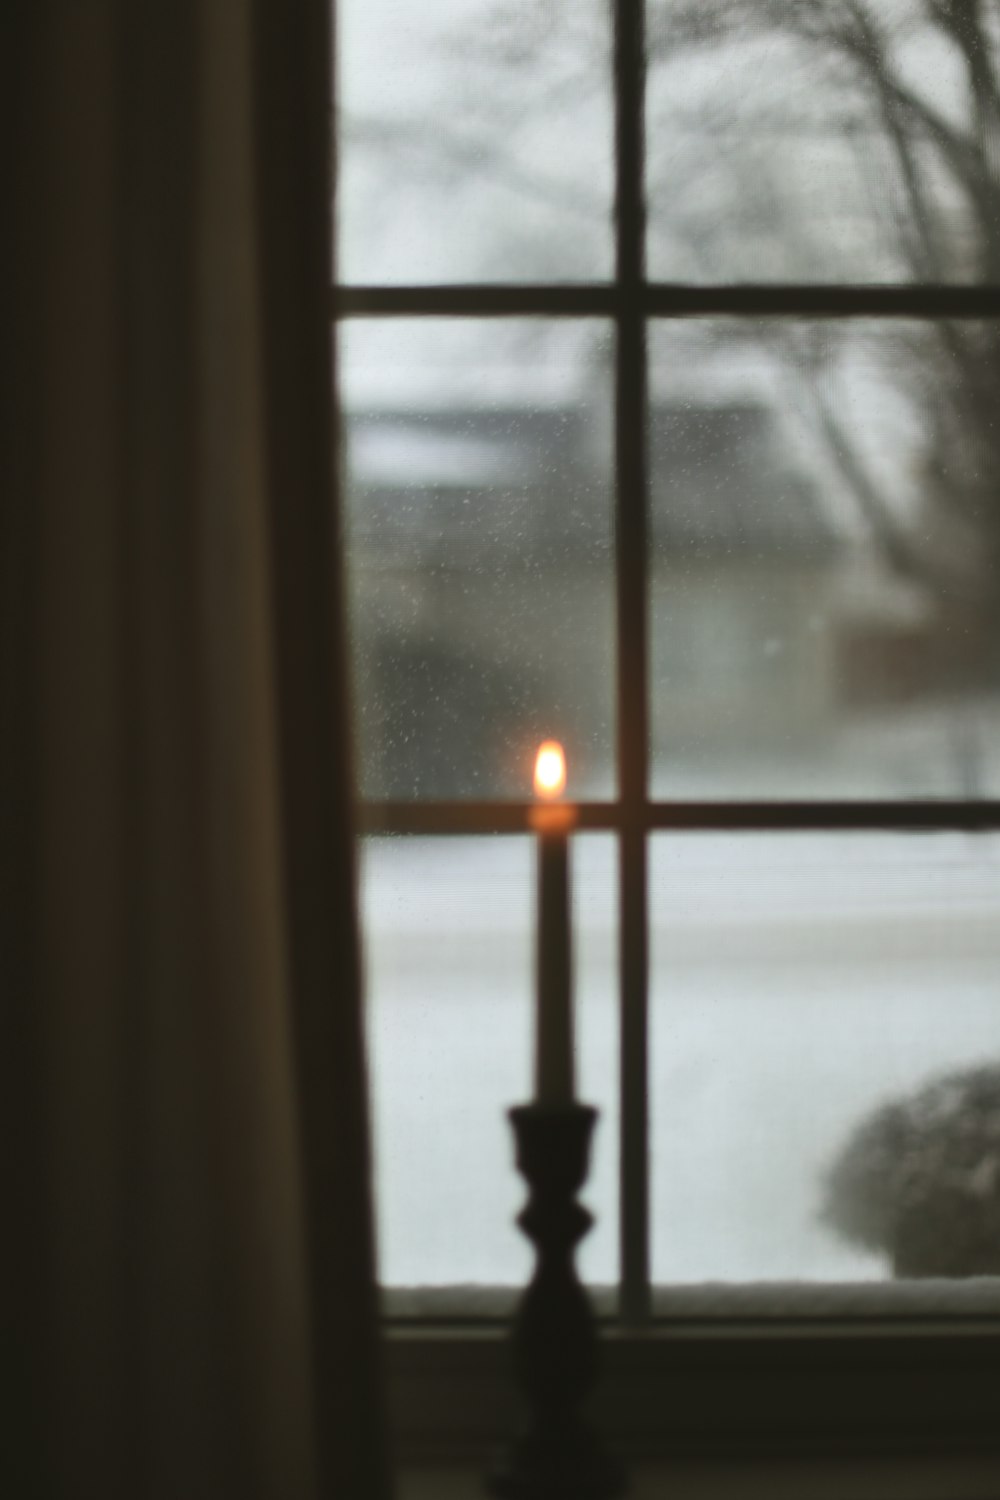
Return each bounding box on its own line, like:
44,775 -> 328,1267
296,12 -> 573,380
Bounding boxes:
361,839 -> 532,1286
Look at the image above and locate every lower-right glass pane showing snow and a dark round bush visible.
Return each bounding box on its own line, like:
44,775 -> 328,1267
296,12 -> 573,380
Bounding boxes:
651,834 -> 1000,1283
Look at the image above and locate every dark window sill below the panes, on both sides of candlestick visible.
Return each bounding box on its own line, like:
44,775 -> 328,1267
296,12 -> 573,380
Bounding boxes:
385,1317 -> 1000,1458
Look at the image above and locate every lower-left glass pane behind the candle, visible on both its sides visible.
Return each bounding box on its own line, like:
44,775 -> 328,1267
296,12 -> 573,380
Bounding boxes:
361,836 -> 619,1310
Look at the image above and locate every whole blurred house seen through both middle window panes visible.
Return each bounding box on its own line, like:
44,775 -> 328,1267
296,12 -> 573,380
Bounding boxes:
348,399 -> 953,798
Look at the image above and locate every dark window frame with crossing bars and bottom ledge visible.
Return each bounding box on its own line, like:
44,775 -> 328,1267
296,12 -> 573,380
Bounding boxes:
328,0 -> 1000,1457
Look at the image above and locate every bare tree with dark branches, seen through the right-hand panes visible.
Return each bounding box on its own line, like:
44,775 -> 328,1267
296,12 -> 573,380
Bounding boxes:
649,0 -> 1000,636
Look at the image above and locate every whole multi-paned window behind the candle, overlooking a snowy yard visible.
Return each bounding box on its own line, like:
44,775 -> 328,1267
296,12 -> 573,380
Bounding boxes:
333,0 -> 1000,1464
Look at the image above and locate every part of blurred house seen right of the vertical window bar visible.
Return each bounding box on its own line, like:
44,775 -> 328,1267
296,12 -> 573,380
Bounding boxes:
649,402 -> 846,779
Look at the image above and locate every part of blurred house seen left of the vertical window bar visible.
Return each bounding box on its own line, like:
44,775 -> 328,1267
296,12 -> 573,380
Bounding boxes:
348,408 -> 613,798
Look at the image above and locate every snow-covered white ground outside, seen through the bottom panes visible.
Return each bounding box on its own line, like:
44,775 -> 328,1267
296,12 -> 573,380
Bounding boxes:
363,834 -> 1000,1286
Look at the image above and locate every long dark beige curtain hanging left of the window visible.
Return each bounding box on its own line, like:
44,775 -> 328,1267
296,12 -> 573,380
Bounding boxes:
0,0 -> 387,1500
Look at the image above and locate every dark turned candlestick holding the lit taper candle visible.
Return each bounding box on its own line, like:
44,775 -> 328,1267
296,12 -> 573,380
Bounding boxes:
486,1104 -> 625,1500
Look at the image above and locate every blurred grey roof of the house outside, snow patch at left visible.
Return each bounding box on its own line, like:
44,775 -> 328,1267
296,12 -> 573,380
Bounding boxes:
348,402 -> 837,558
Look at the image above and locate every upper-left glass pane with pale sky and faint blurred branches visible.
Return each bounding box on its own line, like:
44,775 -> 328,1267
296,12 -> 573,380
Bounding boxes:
337,0 -> 612,284
